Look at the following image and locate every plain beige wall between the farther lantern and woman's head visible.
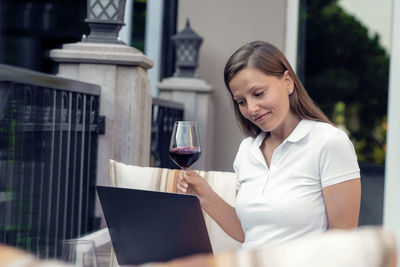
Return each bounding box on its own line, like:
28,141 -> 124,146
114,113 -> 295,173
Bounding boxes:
178,0 -> 287,171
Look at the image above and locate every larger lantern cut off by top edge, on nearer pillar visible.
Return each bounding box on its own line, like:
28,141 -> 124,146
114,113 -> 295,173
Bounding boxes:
82,0 -> 126,44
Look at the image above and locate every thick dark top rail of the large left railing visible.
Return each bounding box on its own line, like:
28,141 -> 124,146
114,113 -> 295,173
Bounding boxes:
0,64 -> 100,96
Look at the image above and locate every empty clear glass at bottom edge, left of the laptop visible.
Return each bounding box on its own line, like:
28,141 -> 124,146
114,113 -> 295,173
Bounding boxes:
61,239 -> 98,267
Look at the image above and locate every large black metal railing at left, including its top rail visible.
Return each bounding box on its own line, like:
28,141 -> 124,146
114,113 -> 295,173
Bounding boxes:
0,65 -> 100,258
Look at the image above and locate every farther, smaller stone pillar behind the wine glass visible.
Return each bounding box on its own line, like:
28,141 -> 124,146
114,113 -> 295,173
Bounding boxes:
157,77 -> 214,170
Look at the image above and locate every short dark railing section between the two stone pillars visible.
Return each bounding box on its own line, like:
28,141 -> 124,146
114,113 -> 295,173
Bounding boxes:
150,97 -> 184,169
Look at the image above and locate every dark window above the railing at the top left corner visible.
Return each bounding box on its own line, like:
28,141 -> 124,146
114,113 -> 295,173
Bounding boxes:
0,0 -> 89,73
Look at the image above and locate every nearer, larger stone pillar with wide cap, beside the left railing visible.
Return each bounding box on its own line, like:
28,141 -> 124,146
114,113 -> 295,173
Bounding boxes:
50,42 -> 153,224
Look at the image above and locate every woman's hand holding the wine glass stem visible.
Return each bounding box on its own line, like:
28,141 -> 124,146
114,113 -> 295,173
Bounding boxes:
176,170 -> 214,206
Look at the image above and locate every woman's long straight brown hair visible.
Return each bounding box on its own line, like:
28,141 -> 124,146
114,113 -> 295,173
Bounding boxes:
224,41 -> 332,137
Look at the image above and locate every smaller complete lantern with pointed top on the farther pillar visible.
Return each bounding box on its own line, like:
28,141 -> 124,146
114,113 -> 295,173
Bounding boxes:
171,19 -> 203,77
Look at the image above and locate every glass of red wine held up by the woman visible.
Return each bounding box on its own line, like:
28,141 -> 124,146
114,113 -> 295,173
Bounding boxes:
169,121 -> 201,170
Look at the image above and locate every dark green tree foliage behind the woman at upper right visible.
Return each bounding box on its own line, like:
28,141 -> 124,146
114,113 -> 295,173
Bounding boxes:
301,0 -> 389,163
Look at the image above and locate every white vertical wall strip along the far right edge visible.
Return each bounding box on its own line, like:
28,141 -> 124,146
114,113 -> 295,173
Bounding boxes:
383,0 -> 400,266
